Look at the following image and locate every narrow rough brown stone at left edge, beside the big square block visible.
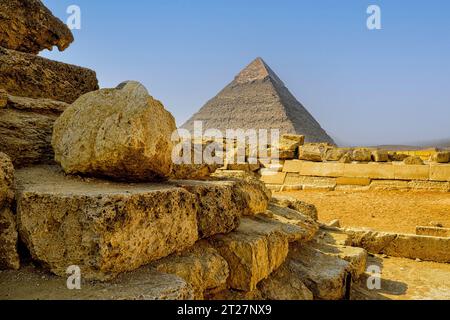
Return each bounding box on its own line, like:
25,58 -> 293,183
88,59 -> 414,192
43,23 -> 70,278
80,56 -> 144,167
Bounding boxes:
0,153 -> 20,270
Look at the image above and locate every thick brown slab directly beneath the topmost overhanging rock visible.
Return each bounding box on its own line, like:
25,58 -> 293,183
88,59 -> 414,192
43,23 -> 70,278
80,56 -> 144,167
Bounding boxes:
0,47 -> 98,103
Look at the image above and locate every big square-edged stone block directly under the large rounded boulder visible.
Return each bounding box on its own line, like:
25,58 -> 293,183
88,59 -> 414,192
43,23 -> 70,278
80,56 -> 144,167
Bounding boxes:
16,167 -> 198,280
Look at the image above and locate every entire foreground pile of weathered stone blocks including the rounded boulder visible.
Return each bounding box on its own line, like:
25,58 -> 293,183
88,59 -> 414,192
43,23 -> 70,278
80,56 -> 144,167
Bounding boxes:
0,0 -> 367,300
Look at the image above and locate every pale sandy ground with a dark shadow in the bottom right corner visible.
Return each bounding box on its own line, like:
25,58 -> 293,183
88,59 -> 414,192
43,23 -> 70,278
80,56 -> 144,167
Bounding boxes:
352,256 -> 450,300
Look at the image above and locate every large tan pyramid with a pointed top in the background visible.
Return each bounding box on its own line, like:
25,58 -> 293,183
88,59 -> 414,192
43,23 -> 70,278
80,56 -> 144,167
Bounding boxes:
182,58 -> 335,144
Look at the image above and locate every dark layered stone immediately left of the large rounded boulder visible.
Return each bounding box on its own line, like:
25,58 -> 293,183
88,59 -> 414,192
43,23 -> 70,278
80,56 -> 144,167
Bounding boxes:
0,95 -> 69,168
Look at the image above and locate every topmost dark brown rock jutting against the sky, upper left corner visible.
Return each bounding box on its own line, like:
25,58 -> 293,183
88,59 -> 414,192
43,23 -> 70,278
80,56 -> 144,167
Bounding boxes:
0,0 -> 74,54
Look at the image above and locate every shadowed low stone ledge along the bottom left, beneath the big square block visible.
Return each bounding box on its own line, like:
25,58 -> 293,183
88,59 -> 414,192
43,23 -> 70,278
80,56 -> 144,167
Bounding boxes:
0,265 -> 194,300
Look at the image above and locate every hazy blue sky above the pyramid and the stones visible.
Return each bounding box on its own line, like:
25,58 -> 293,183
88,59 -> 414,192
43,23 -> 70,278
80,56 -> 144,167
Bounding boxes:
43,0 -> 450,144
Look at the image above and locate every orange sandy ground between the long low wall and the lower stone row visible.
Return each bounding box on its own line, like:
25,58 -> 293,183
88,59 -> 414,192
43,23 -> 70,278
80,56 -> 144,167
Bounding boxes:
283,191 -> 450,233
